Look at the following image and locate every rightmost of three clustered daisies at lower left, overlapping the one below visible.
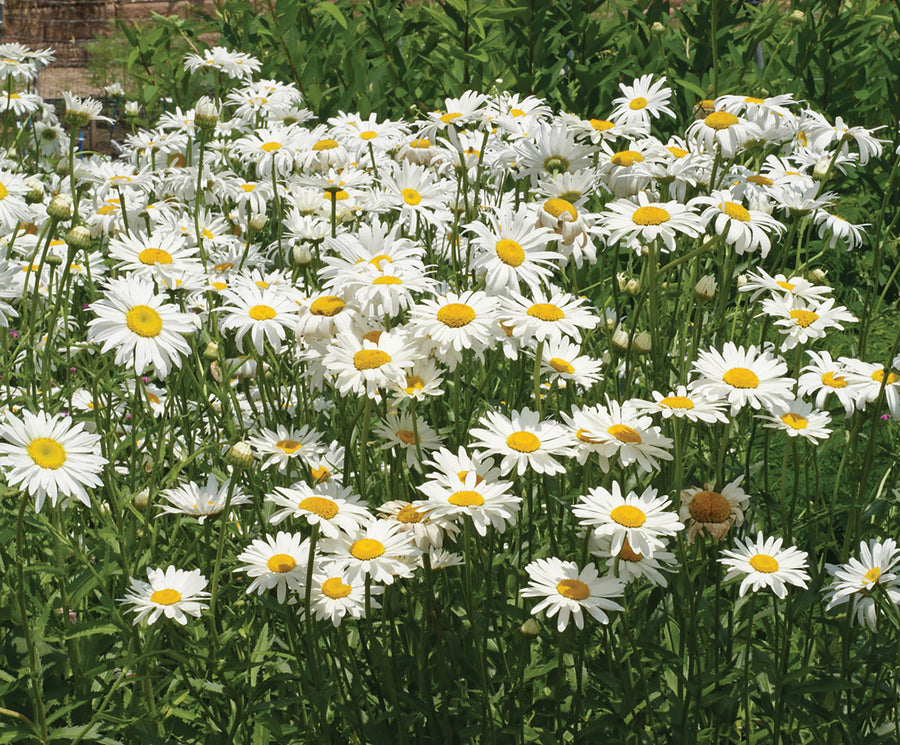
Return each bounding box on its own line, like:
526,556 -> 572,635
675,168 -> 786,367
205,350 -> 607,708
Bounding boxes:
322,520 -> 420,585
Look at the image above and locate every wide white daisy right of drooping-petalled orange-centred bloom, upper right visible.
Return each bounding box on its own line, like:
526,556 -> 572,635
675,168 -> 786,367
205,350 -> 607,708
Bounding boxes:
603,191 -> 703,252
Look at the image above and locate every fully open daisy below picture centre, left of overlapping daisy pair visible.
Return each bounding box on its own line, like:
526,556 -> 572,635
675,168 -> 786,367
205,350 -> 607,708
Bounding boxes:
469,409 -> 571,476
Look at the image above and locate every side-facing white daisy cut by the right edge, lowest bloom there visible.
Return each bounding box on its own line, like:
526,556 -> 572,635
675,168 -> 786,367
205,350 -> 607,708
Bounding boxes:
825,538 -> 900,631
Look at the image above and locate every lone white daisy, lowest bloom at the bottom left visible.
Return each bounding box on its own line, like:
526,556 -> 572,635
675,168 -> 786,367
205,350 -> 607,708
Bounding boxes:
119,565 -> 210,626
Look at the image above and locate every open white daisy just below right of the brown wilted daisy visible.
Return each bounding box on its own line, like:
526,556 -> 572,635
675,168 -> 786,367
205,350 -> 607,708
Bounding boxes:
719,532 -> 809,598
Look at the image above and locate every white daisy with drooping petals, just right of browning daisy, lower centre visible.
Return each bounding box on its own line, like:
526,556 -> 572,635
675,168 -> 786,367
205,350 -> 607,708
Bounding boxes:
413,471 -> 522,536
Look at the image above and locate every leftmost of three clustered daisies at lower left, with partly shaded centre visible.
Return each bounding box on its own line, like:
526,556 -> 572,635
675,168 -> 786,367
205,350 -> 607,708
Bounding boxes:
233,531 -> 309,603
